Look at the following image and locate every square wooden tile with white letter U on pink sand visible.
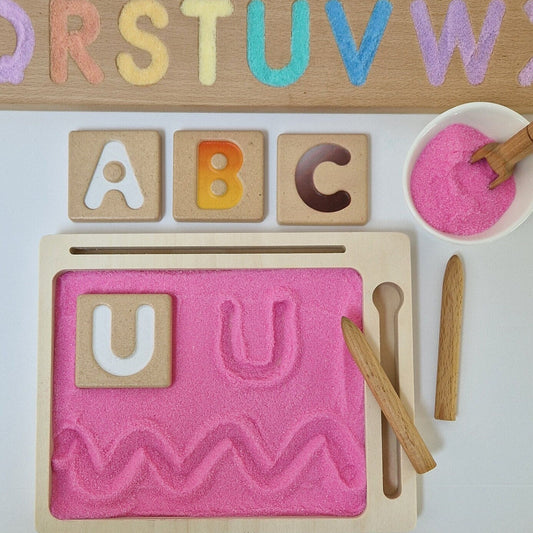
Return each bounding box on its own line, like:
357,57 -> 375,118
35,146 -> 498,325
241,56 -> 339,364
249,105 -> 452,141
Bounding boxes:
76,294 -> 172,388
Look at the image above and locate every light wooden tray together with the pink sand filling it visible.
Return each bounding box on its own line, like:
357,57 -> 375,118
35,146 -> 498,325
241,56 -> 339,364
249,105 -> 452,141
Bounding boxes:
36,233 -> 417,533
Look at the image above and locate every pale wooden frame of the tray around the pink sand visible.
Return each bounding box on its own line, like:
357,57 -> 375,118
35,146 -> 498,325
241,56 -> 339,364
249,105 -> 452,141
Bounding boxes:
36,233 -> 417,533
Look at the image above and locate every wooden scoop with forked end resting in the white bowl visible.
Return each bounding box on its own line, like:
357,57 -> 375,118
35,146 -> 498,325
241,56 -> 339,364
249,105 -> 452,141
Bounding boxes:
470,122 -> 533,189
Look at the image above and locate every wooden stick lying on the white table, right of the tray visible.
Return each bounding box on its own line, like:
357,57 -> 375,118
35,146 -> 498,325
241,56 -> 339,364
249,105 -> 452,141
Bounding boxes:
435,255 -> 464,420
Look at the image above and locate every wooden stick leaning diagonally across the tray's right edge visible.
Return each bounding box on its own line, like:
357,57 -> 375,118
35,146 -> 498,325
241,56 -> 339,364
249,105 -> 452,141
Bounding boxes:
342,317 -> 437,474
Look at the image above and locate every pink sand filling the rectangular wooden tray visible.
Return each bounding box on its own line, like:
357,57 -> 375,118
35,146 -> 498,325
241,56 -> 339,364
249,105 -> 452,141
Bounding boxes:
50,269 -> 366,519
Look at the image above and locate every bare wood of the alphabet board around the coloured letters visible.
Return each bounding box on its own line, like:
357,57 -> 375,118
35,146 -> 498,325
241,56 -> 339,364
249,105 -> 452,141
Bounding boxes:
0,0 -> 533,113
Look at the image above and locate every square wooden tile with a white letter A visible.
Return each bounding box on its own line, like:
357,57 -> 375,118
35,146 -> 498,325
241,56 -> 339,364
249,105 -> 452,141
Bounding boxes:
68,131 -> 161,222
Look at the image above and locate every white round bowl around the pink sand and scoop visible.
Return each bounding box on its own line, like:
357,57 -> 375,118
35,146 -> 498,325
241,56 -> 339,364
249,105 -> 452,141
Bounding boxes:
403,102 -> 533,244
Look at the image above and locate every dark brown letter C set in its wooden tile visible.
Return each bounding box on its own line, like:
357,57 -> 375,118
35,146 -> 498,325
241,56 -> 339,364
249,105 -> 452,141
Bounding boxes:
294,144 -> 351,213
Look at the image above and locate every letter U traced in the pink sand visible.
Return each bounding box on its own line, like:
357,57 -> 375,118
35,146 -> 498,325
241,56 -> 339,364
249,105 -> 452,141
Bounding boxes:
216,289 -> 299,386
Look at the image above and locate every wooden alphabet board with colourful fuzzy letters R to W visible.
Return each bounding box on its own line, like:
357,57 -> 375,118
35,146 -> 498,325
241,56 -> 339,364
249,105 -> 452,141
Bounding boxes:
0,0 -> 533,113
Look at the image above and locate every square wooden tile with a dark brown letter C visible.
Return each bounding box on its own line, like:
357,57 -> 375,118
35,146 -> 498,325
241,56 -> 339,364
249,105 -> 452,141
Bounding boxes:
277,134 -> 368,225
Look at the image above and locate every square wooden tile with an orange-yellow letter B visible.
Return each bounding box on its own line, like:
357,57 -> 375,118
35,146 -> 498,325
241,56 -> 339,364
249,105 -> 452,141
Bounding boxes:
173,131 -> 264,222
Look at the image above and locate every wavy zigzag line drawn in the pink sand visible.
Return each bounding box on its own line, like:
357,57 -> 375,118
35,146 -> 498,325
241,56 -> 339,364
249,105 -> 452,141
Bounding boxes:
52,415 -> 366,502
